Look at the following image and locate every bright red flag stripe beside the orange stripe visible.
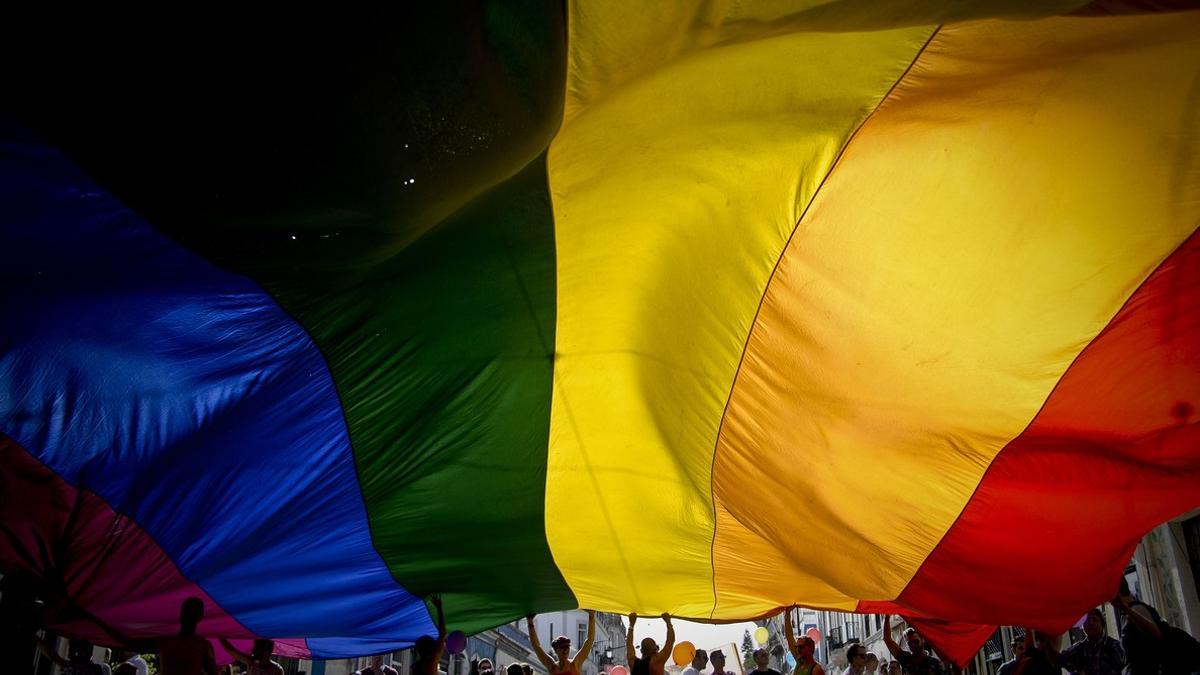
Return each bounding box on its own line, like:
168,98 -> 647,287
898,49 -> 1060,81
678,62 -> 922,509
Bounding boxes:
871,228 -> 1200,656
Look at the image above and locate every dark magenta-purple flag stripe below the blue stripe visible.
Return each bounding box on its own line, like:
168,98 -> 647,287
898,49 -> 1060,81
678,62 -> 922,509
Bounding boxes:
0,435 -> 308,658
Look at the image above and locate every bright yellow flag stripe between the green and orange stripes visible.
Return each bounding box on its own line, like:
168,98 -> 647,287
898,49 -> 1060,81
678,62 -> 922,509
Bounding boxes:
546,1 -> 932,616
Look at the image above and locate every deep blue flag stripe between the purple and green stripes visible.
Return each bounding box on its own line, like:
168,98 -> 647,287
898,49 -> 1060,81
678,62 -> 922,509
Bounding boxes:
0,121 -> 434,657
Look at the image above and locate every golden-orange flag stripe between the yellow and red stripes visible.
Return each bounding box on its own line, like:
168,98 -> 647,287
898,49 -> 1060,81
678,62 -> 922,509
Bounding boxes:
714,13 -> 1200,617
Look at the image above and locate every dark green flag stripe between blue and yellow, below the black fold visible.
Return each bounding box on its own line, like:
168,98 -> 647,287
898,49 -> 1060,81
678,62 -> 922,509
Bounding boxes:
275,157 -> 576,629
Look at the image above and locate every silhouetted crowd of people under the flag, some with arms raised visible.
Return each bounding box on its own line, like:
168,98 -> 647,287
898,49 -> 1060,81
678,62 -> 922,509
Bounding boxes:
23,571 -> 1200,675
